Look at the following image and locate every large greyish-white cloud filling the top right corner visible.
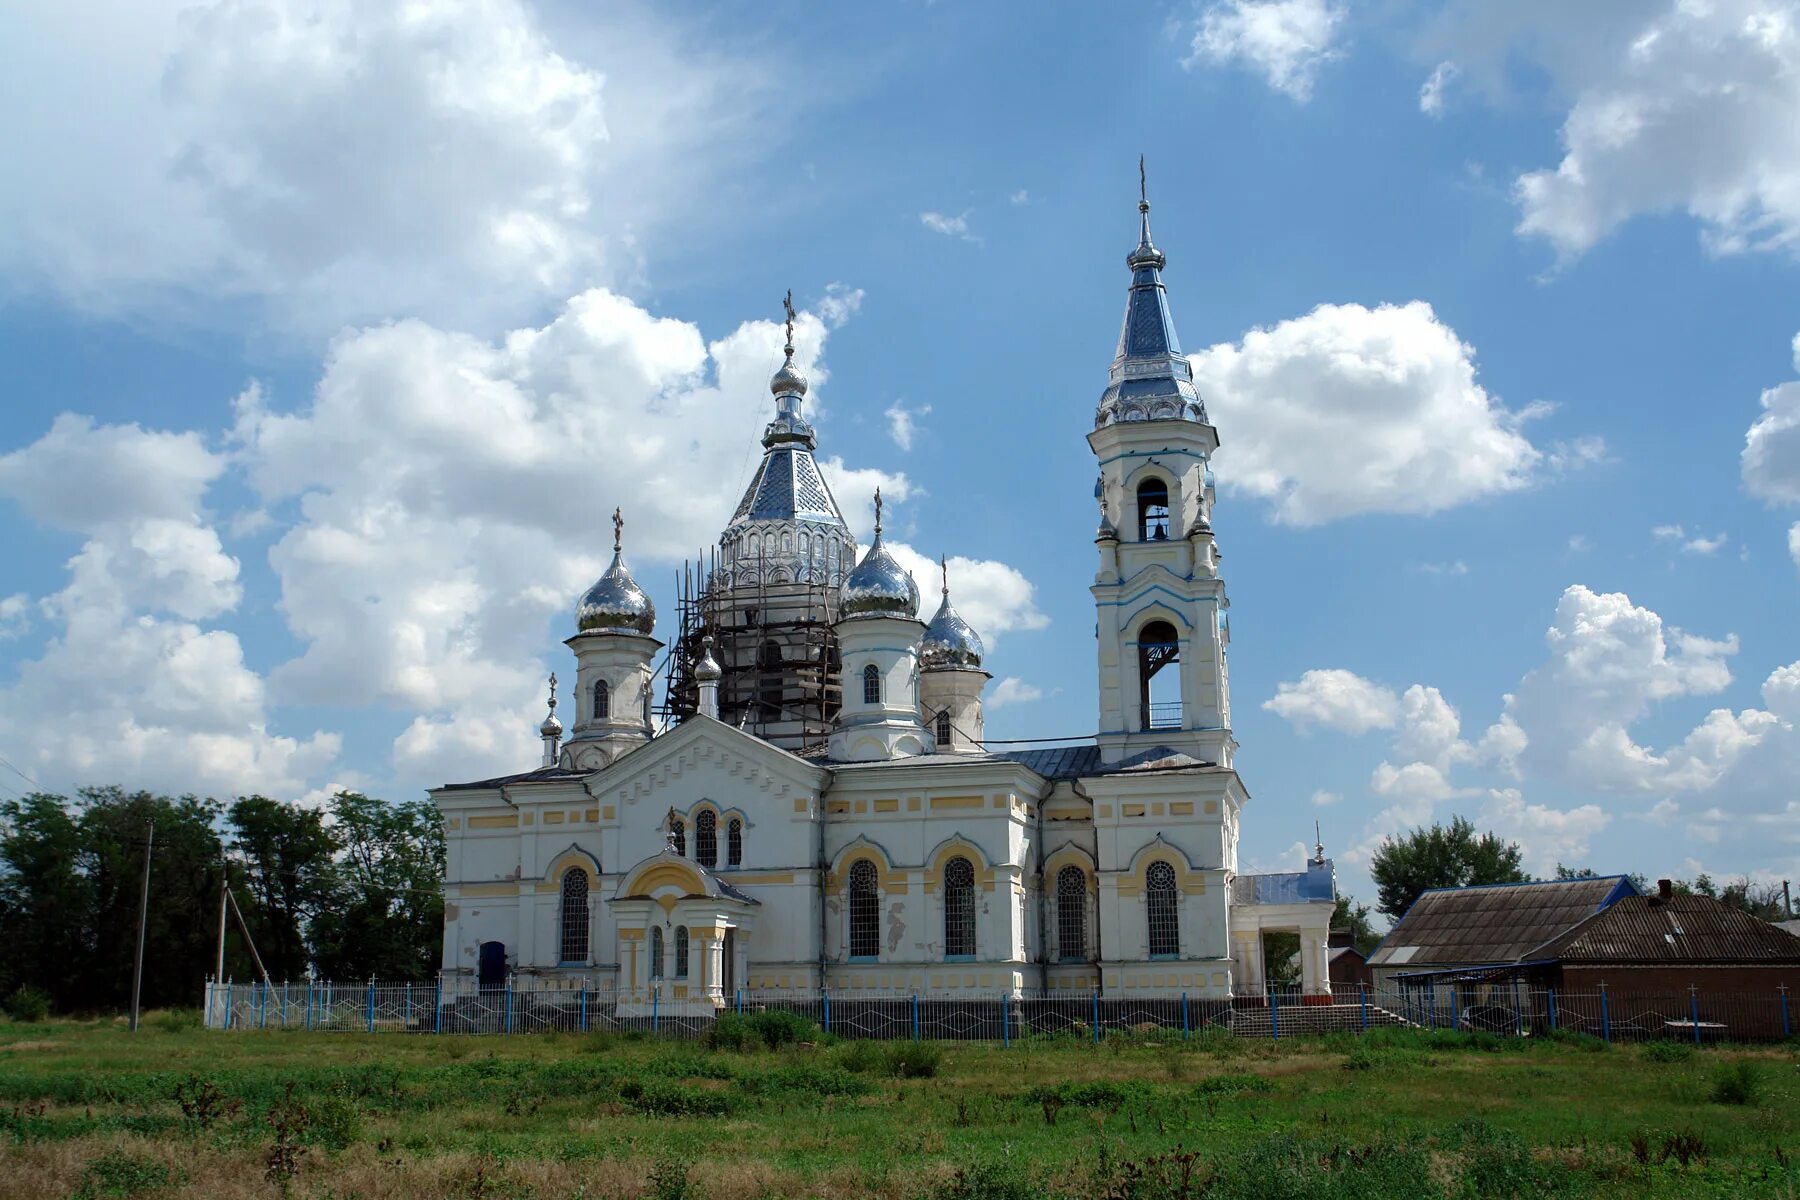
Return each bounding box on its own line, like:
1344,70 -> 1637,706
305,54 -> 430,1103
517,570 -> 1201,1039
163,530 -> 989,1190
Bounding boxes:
1433,0 -> 1800,259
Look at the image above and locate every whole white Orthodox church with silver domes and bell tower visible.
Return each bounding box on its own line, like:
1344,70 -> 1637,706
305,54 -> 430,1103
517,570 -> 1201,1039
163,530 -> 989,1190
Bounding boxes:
430,183 -> 1336,1013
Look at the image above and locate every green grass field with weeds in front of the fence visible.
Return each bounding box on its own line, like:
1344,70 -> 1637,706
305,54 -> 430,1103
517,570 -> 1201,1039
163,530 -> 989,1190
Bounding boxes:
0,1013 -> 1800,1200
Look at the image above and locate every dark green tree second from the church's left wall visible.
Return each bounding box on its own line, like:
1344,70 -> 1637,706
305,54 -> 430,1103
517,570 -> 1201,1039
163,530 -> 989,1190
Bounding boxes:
230,795 -> 338,979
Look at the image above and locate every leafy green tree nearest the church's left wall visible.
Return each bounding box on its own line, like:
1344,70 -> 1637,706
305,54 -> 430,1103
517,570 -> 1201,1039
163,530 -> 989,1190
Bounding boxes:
308,792 -> 445,979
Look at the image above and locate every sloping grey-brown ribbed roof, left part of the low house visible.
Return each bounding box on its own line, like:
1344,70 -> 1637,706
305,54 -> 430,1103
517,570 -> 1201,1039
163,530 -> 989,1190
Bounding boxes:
1368,874 -> 1636,966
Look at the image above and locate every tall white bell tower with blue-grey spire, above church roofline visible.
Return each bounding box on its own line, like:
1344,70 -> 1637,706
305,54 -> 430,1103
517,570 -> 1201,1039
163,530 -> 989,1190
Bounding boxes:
1087,160 -> 1237,766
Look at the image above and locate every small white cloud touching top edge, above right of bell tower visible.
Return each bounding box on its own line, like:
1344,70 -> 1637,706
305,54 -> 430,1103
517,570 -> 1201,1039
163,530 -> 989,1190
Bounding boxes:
1184,0 -> 1345,103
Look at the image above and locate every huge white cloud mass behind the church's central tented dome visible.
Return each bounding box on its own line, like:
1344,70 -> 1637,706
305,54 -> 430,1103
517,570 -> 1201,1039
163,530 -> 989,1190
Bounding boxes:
234,290 -> 1046,783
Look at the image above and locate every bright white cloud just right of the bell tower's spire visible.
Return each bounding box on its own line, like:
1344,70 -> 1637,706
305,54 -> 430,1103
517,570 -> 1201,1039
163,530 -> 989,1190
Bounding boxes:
1193,300 -> 1543,525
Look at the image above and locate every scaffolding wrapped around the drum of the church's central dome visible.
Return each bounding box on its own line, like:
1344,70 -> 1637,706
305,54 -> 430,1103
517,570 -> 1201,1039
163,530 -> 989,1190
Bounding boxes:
657,549 -> 842,752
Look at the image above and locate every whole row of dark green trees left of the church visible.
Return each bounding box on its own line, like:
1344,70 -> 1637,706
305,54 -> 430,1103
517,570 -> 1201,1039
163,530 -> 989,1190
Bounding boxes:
0,788 -> 445,1013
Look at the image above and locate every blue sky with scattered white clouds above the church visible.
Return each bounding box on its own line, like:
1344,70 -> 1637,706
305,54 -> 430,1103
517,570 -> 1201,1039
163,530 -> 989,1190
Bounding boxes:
0,0 -> 1800,921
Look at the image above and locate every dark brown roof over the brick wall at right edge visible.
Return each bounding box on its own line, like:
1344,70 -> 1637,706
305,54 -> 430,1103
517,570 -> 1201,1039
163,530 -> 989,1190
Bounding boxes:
1532,896 -> 1800,964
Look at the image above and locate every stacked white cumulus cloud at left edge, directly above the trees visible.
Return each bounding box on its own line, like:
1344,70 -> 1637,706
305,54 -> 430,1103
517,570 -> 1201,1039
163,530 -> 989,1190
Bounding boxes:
0,414 -> 340,795
